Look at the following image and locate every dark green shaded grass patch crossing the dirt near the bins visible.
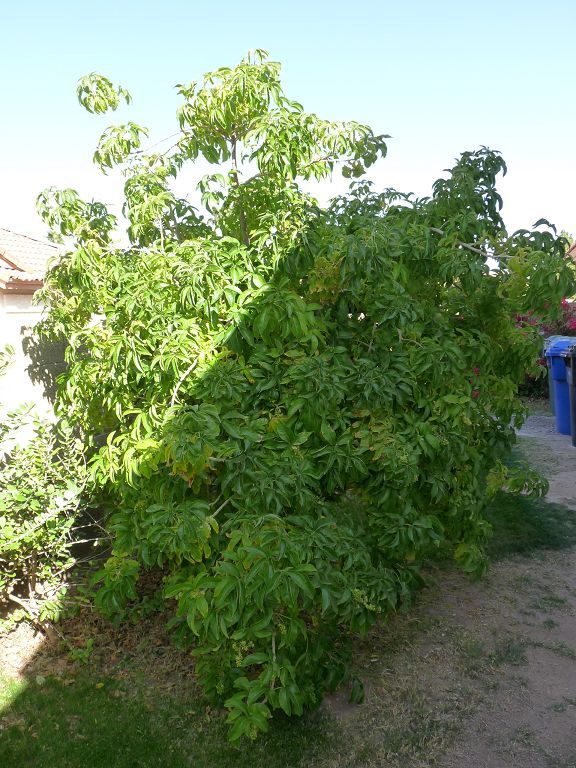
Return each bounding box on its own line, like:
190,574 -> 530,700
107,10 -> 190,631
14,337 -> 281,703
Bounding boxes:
487,493 -> 576,560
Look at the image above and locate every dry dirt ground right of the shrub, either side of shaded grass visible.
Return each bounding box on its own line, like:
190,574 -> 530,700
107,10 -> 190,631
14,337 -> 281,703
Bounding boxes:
320,413 -> 576,768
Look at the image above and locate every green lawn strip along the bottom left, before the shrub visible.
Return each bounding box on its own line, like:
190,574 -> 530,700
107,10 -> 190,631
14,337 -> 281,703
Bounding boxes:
0,672 -> 338,768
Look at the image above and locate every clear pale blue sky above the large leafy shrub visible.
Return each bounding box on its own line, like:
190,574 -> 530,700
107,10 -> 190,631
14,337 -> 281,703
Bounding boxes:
0,0 -> 576,235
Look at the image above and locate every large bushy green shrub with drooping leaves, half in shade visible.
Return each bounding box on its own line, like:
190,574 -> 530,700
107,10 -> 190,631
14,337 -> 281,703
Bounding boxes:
39,51 -> 572,740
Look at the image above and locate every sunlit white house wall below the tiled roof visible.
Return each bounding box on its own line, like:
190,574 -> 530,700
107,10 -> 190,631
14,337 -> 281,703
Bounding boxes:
0,291 -> 56,413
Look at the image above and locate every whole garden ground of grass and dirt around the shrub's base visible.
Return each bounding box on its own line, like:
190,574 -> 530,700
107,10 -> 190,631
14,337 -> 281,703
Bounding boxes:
0,402 -> 576,768
